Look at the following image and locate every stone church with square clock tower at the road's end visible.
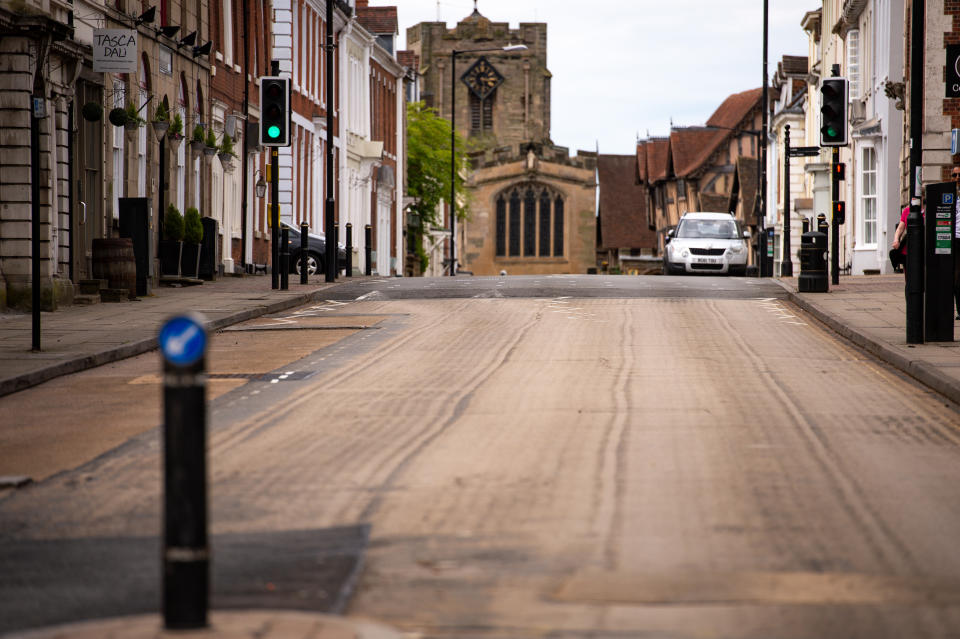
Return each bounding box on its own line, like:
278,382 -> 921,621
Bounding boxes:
407,3 -> 597,275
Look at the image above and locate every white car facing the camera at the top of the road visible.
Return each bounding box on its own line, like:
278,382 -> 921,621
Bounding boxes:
663,213 -> 750,275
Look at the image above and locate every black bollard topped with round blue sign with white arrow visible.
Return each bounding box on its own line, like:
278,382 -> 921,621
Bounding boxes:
157,315 -> 210,630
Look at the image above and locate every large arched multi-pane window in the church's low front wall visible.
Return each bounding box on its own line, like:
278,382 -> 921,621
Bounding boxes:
496,184 -> 564,258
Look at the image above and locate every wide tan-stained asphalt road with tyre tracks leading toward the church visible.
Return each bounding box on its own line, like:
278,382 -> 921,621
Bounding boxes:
0,277 -> 960,639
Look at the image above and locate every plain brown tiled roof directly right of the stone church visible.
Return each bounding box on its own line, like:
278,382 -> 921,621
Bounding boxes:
597,155 -> 656,249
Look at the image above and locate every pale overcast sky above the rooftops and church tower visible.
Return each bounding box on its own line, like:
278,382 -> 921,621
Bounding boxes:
370,0 -> 808,155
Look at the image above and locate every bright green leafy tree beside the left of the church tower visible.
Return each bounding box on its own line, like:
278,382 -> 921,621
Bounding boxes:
407,102 -> 465,225
